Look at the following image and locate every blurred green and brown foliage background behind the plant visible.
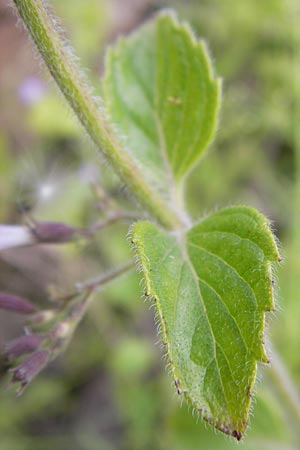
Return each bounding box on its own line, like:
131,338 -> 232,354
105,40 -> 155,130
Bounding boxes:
0,0 -> 300,450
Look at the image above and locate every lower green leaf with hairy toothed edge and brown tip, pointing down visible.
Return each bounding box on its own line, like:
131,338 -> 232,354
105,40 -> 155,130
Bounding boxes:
132,206 -> 279,440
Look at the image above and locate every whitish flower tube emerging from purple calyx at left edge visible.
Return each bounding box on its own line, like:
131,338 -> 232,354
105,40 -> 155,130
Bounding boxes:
0,225 -> 34,251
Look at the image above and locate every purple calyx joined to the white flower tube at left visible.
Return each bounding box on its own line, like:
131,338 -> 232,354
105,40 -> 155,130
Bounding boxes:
31,222 -> 76,244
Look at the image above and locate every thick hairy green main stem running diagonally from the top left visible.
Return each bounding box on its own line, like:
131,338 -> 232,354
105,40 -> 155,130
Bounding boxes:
14,0 -> 183,229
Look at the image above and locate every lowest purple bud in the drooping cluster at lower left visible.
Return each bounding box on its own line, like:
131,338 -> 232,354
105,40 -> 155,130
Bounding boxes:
10,350 -> 50,390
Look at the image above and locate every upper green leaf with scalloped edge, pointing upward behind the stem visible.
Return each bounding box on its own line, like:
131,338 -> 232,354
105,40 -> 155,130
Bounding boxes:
104,13 -> 220,201
